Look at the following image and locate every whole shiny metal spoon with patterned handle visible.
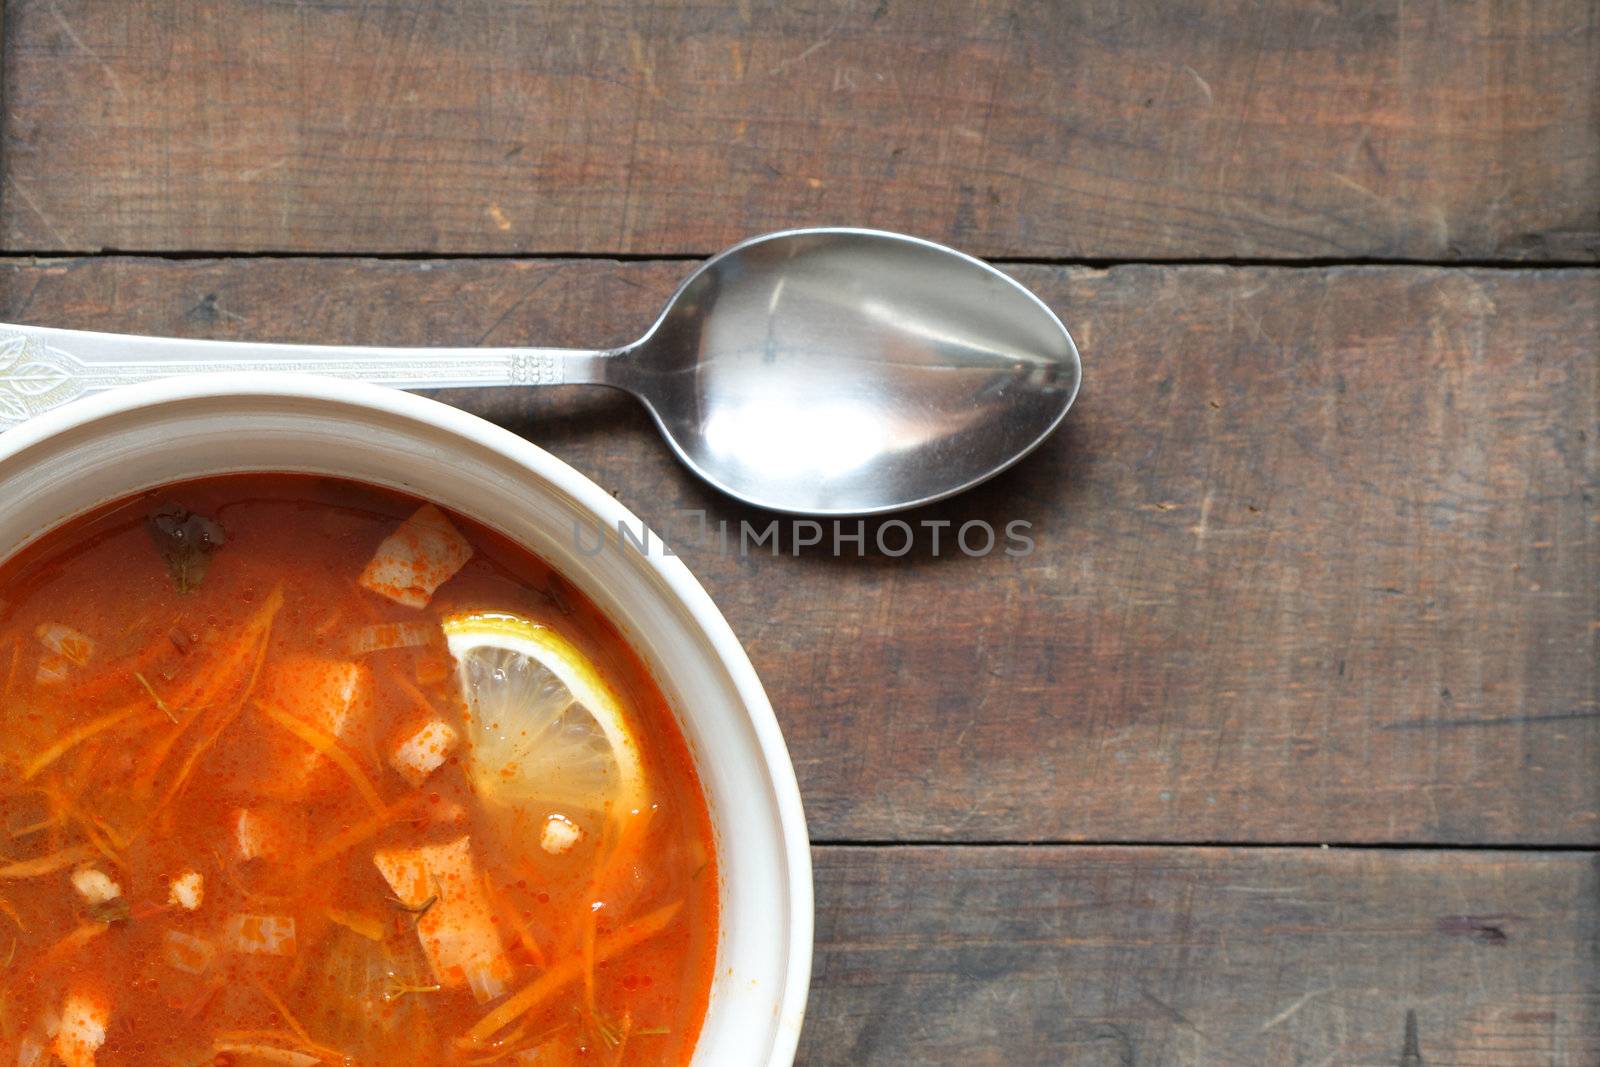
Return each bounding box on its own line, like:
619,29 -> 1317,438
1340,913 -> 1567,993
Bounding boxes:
0,229 -> 1080,515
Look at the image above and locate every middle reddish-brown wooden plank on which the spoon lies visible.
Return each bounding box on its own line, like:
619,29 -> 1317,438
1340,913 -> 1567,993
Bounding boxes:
0,259 -> 1600,845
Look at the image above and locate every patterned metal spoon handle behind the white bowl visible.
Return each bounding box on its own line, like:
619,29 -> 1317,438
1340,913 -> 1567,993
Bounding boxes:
0,323 -> 616,430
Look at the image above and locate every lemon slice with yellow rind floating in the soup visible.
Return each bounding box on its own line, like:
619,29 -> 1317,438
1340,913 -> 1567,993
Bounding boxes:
443,613 -> 645,814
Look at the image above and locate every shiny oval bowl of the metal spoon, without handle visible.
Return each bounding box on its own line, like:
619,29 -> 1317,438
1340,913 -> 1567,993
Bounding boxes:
608,229 -> 1082,515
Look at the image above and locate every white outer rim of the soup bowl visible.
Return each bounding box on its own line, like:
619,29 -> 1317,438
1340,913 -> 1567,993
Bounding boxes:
0,371 -> 816,1065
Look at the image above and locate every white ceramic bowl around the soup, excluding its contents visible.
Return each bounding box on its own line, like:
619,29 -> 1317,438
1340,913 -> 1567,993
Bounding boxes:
0,374 -> 813,1067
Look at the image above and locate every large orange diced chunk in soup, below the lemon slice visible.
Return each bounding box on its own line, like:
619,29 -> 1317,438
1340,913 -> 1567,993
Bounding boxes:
373,837 -> 512,1003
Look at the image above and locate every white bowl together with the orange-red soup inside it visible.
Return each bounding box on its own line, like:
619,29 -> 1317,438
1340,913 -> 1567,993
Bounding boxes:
0,376 -> 811,1067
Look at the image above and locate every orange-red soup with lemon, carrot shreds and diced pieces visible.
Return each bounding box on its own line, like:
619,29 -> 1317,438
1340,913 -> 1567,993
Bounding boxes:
0,475 -> 717,1067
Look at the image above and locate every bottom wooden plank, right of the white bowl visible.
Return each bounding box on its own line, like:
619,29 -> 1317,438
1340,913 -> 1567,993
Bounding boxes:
798,848 -> 1600,1067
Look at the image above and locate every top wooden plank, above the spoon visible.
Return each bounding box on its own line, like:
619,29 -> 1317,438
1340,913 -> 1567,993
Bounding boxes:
0,0 -> 1600,261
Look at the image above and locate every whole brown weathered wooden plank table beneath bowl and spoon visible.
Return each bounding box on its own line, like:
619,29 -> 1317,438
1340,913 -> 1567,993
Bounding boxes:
0,0 -> 1600,1067
